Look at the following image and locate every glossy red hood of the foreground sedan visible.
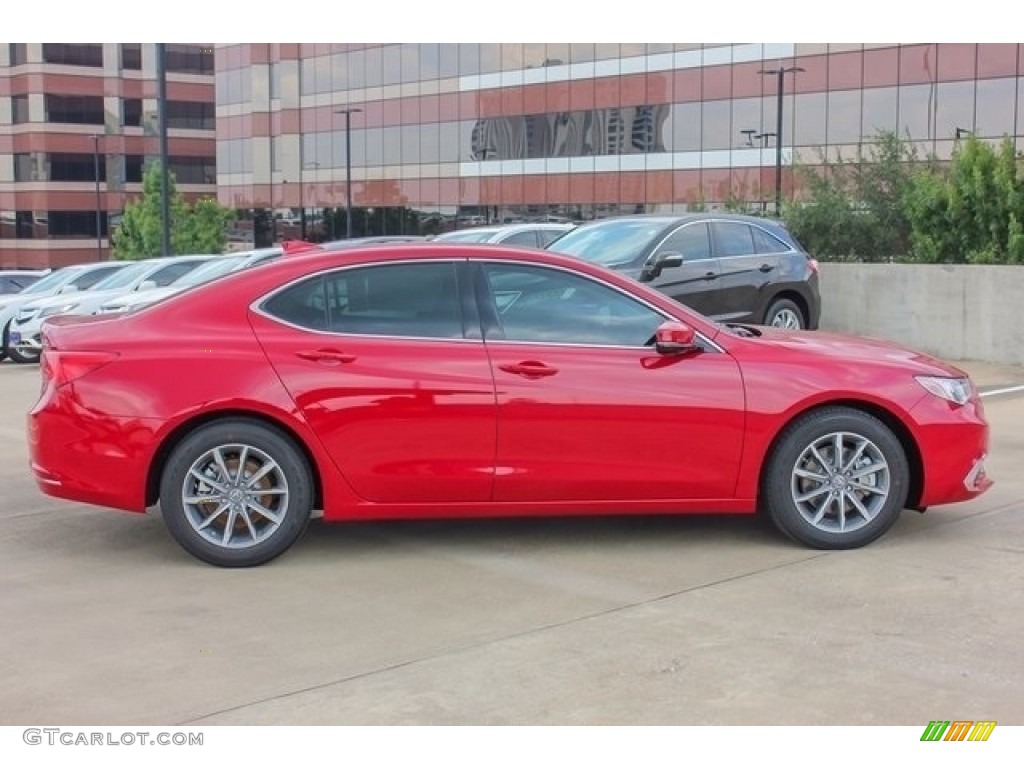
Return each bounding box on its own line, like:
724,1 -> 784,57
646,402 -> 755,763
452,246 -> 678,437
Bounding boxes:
726,327 -> 967,376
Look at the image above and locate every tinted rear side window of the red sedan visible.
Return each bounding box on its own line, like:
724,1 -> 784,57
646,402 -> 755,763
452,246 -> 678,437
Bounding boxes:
263,262 -> 463,339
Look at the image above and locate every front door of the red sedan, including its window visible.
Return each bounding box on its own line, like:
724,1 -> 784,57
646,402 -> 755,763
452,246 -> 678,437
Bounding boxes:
480,263 -> 743,502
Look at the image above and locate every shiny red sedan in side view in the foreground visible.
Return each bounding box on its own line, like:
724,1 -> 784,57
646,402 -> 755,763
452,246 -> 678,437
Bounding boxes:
29,243 -> 990,565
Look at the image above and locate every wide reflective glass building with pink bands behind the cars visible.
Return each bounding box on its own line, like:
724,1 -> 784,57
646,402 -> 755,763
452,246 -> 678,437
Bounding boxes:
215,43 -> 1024,245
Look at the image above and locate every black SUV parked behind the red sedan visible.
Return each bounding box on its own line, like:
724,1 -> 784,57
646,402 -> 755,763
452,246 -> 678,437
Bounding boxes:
548,213 -> 821,330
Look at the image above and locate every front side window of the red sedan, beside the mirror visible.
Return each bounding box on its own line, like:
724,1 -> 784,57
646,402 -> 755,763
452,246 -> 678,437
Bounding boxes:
484,264 -> 665,347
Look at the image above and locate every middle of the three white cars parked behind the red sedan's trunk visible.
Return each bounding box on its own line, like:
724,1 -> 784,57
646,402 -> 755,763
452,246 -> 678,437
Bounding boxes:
7,254 -> 223,362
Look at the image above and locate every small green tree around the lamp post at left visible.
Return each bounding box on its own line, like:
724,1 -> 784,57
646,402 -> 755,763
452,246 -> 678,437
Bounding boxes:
112,163 -> 234,259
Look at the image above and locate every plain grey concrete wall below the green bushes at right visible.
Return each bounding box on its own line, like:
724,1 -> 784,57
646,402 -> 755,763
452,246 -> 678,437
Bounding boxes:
821,263 -> 1024,365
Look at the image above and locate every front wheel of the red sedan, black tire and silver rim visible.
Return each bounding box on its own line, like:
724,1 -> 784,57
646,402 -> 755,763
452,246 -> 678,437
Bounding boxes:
761,408 -> 910,549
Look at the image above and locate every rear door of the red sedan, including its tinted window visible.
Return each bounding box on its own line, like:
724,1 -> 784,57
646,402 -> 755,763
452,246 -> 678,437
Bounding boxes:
252,260 -> 496,504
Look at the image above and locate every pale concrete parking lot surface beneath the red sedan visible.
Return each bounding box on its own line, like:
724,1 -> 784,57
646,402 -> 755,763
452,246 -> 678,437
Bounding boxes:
0,362 -> 1024,727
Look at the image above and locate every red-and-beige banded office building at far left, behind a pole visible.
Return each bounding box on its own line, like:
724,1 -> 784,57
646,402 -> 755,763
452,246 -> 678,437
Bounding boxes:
0,43 -> 217,267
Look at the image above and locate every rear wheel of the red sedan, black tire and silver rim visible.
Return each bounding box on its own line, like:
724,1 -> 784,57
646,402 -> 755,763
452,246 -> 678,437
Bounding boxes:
160,419 -> 313,567
